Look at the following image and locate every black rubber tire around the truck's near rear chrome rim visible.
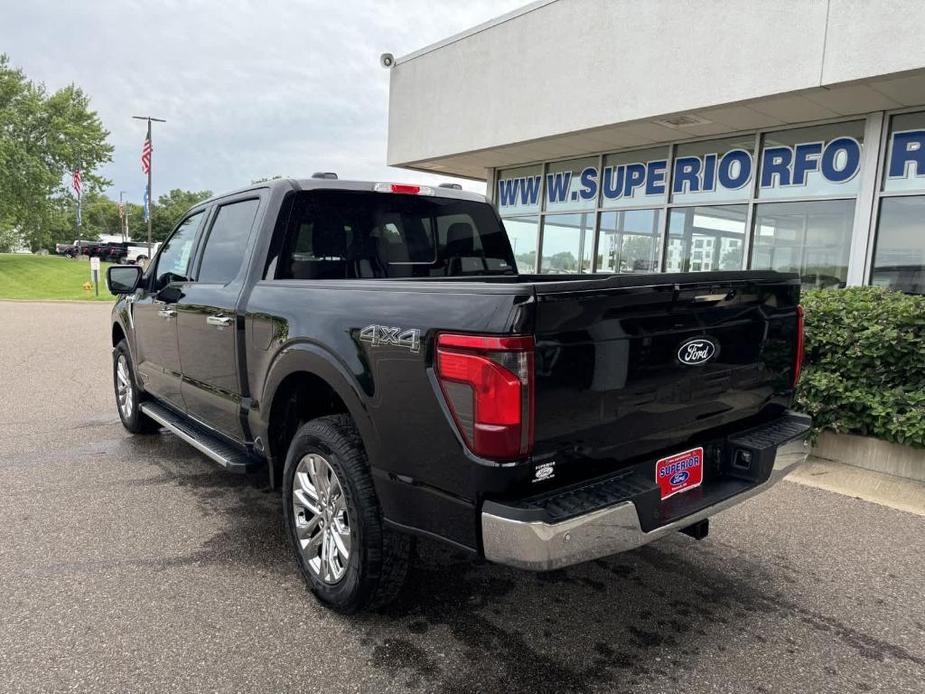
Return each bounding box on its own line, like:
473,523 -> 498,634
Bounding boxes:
283,415 -> 413,614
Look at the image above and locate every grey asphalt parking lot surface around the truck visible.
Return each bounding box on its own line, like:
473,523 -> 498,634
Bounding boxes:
0,302 -> 925,693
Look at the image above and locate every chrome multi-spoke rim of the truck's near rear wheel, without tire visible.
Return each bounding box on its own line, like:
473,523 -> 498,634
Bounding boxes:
292,453 -> 350,583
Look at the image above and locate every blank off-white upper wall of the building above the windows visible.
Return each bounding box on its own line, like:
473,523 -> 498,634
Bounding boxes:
388,0 -> 925,165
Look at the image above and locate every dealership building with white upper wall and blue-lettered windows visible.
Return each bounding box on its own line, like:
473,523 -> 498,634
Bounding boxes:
388,0 -> 925,293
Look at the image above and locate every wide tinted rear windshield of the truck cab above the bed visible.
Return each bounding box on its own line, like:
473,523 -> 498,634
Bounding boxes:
275,190 -> 516,279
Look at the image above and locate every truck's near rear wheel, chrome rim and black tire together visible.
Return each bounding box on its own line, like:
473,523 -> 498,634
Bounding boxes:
283,415 -> 412,613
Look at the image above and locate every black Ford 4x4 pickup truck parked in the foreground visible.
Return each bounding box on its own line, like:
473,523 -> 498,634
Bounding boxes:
108,178 -> 810,612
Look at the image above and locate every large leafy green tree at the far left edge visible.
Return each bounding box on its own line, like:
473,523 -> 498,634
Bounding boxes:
0,54 -> 112,250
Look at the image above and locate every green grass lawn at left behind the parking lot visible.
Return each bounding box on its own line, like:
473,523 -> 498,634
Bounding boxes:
0,253 -> 115,301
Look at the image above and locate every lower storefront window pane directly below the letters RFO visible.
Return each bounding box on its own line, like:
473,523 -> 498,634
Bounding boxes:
752,200 -> 854,287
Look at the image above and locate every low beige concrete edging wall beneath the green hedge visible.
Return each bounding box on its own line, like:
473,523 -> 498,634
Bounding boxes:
813,431 -> 925,482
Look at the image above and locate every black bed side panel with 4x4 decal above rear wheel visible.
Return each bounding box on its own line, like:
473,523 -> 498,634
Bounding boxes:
245,280 -> 532,500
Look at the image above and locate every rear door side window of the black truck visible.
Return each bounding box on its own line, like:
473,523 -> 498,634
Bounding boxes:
198,199 -> 260,284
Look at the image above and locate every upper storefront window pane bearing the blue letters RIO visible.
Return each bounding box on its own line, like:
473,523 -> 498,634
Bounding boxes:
671,134 -> 755,205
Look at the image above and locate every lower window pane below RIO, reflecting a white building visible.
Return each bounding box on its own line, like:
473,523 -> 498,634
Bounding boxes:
665,205 -> 747,272
